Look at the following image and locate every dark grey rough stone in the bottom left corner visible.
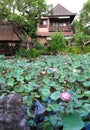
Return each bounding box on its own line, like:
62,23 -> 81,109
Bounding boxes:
0,93 -> 30,130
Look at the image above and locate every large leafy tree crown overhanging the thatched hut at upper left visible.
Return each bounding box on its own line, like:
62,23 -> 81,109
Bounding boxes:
0,0 -> 47,36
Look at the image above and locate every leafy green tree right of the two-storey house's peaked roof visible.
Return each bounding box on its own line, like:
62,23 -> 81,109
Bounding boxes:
72,0 -> 90,35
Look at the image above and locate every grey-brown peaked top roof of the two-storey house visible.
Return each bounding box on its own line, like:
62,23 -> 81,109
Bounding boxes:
47,4 -> 76,16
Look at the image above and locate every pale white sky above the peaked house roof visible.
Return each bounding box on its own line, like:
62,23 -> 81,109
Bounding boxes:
46,0 -> 87,14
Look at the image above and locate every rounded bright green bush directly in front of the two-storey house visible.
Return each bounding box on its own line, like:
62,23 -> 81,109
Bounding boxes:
49,32 -> 66,53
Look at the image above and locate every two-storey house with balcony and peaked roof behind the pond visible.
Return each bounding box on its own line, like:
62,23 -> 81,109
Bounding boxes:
37,4 -> 76,44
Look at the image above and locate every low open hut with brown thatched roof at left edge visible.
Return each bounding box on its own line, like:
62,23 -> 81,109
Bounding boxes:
0,20 -> 21,55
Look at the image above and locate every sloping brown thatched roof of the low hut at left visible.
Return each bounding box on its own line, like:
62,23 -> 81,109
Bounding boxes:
0,21 -> 21,42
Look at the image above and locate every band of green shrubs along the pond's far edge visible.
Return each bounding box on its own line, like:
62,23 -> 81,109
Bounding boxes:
16,35 -> 90,58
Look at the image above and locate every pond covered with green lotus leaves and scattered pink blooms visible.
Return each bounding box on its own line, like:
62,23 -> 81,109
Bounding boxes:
0,54 -> 90,130
